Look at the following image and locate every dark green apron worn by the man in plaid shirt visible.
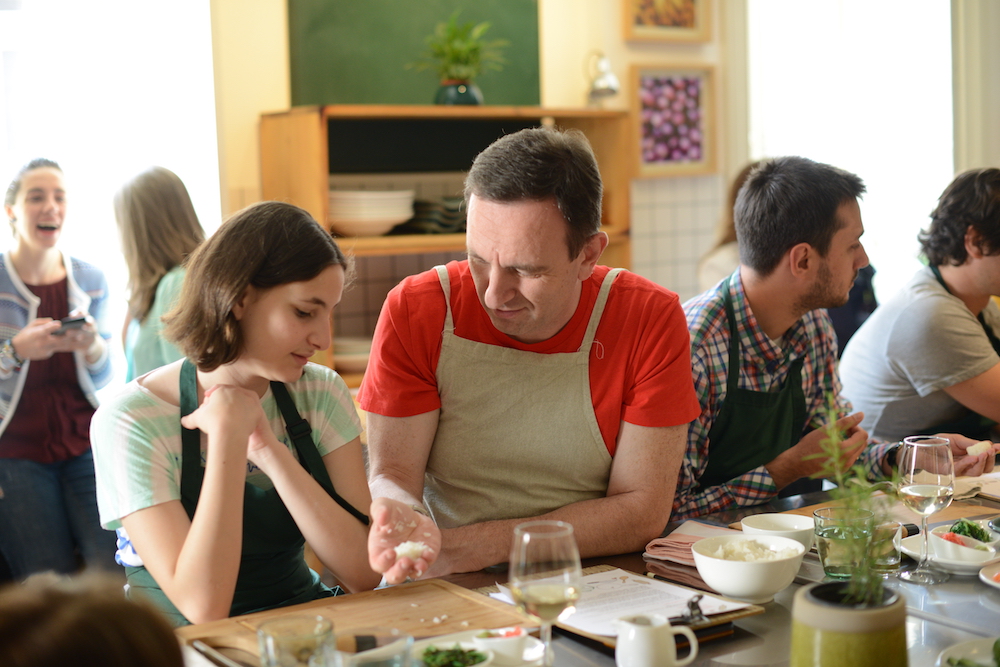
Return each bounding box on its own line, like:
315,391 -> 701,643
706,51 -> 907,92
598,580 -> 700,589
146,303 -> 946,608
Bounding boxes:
699,277 -> 822,495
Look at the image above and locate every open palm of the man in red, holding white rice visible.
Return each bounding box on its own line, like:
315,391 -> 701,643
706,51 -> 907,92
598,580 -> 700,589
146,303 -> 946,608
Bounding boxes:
368,498 -> 441,584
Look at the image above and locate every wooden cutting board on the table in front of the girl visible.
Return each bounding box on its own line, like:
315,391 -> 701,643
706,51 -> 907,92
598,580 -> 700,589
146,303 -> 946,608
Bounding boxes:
177,579 -> 525,655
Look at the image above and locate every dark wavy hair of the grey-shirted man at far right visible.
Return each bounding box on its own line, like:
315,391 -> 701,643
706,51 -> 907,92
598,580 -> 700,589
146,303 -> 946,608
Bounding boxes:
917,169 -> 1000,266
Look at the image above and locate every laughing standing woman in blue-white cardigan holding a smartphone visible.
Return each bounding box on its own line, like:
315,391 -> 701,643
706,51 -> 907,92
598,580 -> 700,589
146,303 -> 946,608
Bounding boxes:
0,158 -> 115,580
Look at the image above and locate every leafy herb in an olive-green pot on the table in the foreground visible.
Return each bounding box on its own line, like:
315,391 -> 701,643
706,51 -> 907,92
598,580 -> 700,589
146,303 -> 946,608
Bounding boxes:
791,402 -> 907,667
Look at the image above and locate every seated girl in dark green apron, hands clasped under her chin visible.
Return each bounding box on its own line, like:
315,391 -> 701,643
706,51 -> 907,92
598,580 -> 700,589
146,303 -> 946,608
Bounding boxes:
91,202 -> 426,625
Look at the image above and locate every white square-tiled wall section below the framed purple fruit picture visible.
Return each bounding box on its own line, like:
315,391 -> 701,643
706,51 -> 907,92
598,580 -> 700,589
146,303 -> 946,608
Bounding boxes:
631,175 -> 735,301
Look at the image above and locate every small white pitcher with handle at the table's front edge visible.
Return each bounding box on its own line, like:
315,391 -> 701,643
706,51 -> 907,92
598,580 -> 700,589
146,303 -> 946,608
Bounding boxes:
615,614 -> 698,667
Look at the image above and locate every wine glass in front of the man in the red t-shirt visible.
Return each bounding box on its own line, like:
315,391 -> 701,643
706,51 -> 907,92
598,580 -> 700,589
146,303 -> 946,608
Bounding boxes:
509,521 -> 583,667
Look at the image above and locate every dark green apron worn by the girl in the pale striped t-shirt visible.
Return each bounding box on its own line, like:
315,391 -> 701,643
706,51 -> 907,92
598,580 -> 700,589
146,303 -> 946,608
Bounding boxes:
125,360 -> 368,625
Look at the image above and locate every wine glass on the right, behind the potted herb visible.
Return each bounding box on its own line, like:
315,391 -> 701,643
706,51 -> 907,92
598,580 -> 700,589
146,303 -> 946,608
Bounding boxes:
899,435 -> 955,584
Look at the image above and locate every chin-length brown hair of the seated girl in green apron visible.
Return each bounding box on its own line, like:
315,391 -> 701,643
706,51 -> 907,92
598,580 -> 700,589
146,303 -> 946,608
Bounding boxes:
163,202 -> 352,371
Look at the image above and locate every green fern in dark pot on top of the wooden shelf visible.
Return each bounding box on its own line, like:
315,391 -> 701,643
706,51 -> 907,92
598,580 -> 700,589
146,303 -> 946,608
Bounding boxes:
407,10 -> 508,104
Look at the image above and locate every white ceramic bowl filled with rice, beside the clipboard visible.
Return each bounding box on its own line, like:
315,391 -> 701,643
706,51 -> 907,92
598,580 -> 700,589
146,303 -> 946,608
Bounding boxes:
691,535 -> 806,604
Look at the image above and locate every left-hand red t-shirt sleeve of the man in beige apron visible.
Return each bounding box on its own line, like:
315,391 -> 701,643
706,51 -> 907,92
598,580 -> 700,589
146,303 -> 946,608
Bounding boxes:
358,271 -> 445,417
